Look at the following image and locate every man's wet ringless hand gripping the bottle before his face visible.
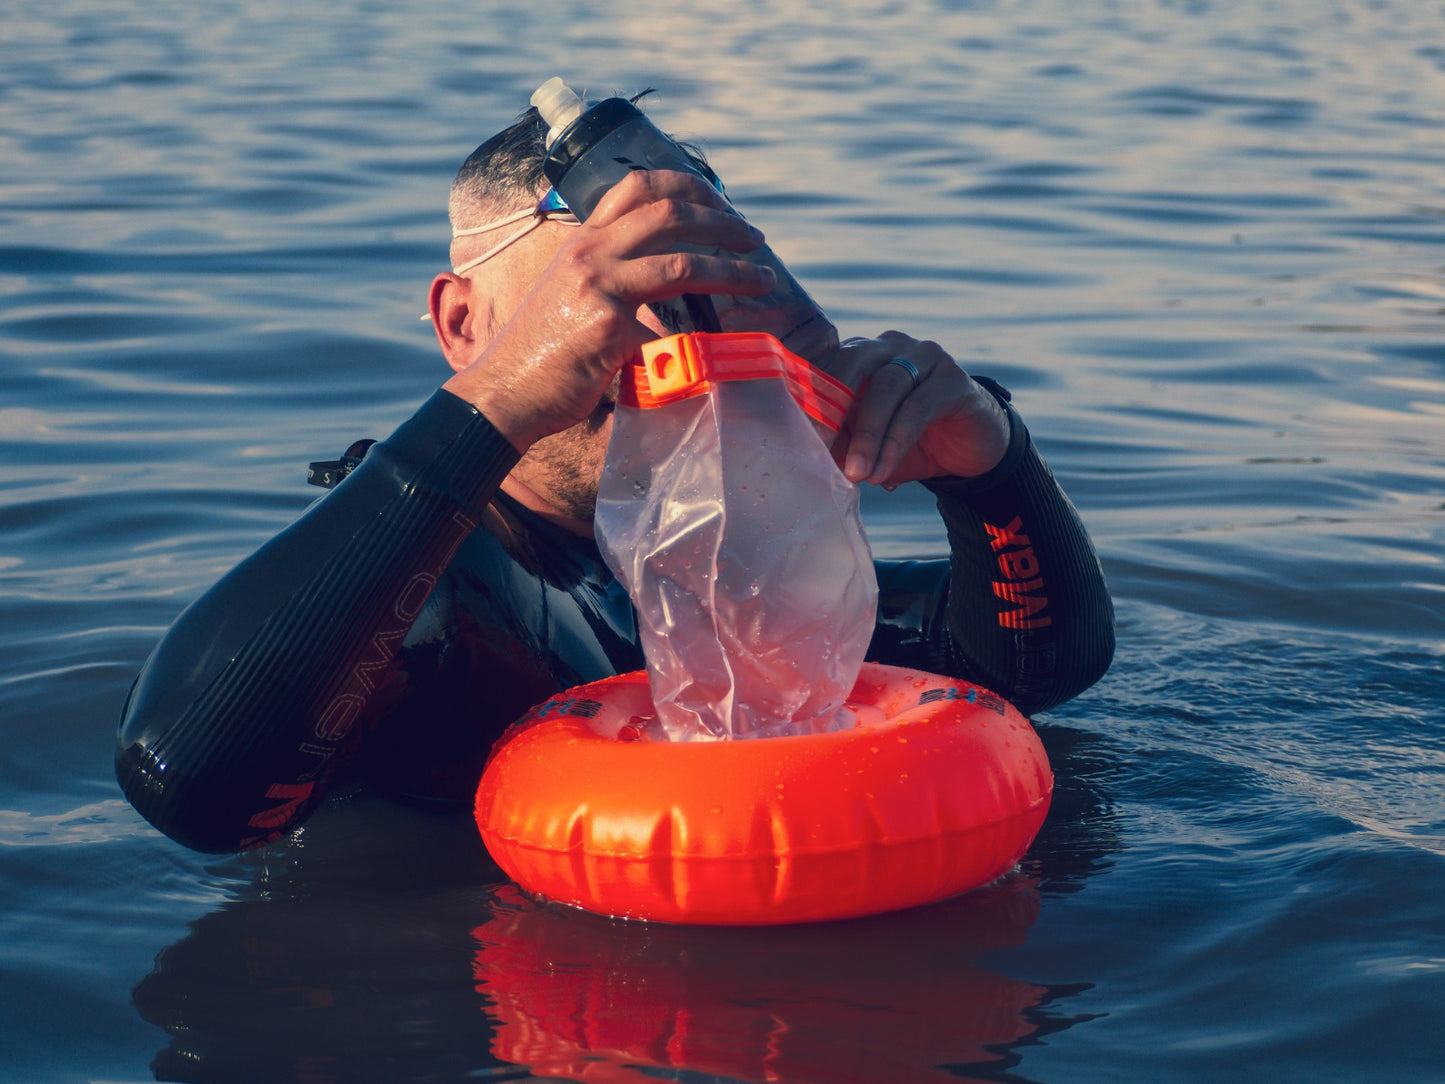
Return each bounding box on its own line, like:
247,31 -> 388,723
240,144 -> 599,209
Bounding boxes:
444,171 -> 773,452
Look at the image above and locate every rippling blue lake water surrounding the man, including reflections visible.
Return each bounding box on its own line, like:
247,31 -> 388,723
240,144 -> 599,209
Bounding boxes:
0,0 -> 1445,1084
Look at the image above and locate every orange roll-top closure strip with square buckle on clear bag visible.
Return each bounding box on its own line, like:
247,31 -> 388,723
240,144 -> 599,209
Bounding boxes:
618,331 -> 853,431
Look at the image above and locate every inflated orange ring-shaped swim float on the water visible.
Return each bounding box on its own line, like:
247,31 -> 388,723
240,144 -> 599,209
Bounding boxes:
477,663 -> 1053,925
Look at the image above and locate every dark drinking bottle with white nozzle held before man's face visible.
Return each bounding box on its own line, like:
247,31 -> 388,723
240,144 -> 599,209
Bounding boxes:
532,78 -> 838,367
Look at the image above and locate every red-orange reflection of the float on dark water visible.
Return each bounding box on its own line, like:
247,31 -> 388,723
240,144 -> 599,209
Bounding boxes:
473,876 -> 1049,1084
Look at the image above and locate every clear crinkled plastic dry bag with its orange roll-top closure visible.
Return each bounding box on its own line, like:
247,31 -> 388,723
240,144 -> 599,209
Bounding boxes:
595,332 -> 879,740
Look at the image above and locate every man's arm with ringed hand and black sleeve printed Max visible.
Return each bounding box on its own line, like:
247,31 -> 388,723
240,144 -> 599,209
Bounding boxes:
834,331 -> 1114,713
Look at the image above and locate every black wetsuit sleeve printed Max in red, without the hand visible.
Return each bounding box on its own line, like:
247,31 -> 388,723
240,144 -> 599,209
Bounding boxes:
871,380 -> 1114,714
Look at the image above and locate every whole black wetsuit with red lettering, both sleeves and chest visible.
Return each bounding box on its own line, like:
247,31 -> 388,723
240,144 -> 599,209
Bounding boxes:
116,384 -> 1114,851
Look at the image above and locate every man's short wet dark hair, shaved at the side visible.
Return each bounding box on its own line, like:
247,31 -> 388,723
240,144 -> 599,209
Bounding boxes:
448,88 -> 712,231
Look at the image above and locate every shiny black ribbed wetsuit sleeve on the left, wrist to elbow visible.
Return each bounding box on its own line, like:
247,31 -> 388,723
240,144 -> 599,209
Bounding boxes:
116,392 -> 517,851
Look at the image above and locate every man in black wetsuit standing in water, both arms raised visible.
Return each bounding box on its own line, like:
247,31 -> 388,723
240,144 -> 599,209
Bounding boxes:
117,111 -> 1114,851
